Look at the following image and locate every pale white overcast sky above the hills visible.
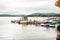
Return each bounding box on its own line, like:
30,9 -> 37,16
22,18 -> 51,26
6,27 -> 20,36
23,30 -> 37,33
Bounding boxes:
0,0 -> 60,15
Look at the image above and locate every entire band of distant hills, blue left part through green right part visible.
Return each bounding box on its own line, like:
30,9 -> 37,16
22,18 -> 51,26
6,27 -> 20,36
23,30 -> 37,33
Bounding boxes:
0,13 -> 60,17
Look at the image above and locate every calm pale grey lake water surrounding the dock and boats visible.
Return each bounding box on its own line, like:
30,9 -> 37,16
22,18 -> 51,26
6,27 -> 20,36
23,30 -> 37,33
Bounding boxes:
0,17 -> 56,40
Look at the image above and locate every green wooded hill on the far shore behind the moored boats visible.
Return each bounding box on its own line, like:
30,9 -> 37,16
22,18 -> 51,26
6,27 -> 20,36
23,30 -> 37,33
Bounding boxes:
27,13 -> 60,17
